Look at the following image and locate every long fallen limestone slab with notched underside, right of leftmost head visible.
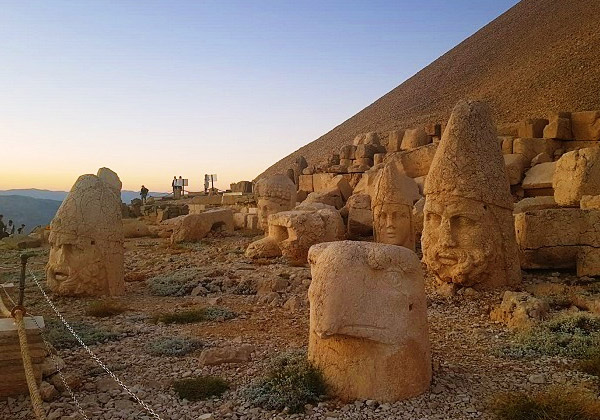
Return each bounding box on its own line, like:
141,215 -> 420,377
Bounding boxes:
171,208 -> 234,244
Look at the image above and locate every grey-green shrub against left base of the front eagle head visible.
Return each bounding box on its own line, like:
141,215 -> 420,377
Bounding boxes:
244,352 -> 327,413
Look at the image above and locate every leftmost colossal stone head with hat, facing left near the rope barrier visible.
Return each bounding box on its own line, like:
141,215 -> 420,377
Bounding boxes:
46,168 -> 124,296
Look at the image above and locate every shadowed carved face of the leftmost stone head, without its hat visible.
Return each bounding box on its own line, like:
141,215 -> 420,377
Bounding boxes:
46,232 -> 107,296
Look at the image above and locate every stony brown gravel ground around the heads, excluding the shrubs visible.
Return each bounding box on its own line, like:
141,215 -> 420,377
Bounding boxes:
0,233 -> 597,420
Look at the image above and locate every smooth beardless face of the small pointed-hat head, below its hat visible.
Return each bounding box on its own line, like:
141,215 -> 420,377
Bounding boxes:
373,203 -> 415,249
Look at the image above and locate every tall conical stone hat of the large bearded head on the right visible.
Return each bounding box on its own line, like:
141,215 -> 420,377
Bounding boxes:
424,100 -> 513,210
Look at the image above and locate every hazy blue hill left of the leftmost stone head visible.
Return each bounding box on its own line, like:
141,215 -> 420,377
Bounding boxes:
0,195 -> 62,233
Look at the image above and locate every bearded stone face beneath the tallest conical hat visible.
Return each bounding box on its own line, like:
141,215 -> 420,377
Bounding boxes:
421,194 -> 494,286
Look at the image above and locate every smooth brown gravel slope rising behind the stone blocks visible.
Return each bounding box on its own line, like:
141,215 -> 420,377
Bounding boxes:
259,0 -> 600,177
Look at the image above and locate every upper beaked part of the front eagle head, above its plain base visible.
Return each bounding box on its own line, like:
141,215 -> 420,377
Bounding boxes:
308,241 -> 427,345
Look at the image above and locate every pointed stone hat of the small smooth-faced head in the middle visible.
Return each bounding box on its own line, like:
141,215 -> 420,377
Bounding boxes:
371,162 -> 420,208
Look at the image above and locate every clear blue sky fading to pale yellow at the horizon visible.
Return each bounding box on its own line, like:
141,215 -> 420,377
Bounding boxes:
0,0 -> 517,191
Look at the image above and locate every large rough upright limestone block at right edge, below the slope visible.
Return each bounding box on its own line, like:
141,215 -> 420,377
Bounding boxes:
553,147 -> 600,206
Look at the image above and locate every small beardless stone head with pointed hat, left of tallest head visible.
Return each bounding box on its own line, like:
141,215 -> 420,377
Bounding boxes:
371,163 -> 420,251
